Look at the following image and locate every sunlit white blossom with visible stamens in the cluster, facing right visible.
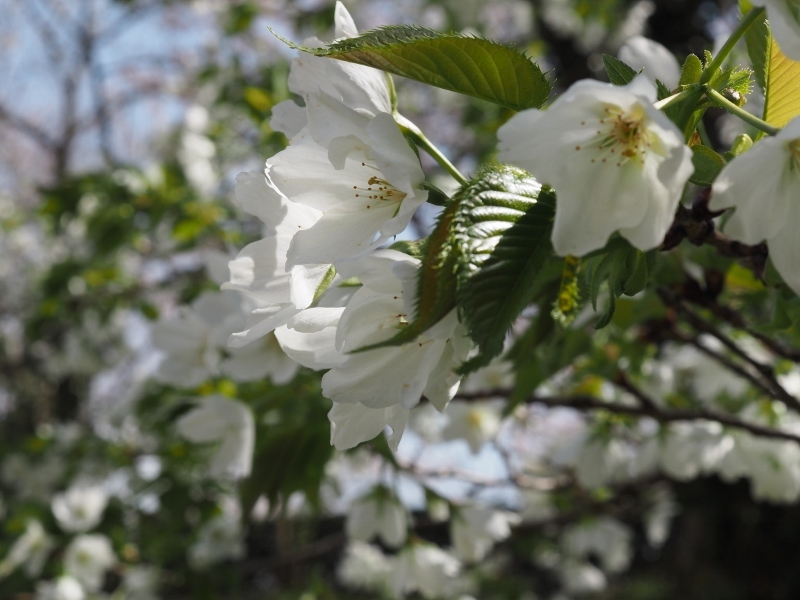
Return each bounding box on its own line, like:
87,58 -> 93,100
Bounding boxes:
267,101 -> 428,268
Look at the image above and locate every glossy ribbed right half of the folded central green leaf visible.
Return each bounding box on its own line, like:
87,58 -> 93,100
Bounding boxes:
453,167 -> 555,372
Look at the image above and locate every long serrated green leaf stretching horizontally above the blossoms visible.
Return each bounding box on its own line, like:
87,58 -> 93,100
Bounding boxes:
273,25 -> 551,110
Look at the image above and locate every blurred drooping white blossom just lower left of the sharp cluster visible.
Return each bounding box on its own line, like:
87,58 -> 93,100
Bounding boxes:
177,396 -> 255,478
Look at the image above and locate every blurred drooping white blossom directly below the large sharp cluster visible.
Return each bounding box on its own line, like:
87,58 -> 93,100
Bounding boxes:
345,487 -> 409,548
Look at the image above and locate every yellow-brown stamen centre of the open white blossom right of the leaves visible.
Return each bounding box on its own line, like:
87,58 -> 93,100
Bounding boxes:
575,104 -> 651,167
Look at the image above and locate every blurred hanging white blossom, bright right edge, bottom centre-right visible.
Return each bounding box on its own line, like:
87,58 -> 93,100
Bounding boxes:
450,506 -> 520,563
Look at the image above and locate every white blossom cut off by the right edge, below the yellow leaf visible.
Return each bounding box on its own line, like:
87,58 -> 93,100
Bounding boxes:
709,117 -> 800,293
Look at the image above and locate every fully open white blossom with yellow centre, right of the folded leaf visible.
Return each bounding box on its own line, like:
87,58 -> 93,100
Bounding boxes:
498,77 -> 694,256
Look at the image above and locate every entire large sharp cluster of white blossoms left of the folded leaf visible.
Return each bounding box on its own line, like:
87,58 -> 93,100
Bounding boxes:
223,3 -> 469,450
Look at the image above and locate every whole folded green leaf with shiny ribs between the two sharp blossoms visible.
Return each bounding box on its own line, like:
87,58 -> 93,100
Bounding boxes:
356,166 -> 555,372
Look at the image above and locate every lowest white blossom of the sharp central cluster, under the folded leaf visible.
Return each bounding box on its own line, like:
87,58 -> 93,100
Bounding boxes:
276,250 -> 469,449
